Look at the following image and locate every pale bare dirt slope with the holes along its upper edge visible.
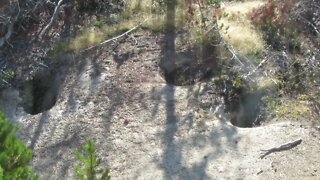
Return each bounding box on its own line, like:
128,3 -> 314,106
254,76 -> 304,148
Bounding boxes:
4,33 -> 320,180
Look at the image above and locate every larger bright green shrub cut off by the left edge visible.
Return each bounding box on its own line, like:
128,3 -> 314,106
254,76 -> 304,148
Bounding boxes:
0,113 -> 38,180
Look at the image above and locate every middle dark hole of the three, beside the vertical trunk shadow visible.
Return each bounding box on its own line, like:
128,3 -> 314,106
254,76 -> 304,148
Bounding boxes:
160,44 -> 219,86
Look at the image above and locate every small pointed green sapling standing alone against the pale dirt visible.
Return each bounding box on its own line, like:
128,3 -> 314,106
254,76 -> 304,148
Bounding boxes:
75,139 -> 110,180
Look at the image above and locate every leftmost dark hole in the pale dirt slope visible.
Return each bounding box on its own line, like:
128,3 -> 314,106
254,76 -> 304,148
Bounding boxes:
19,72 -> 61,115
